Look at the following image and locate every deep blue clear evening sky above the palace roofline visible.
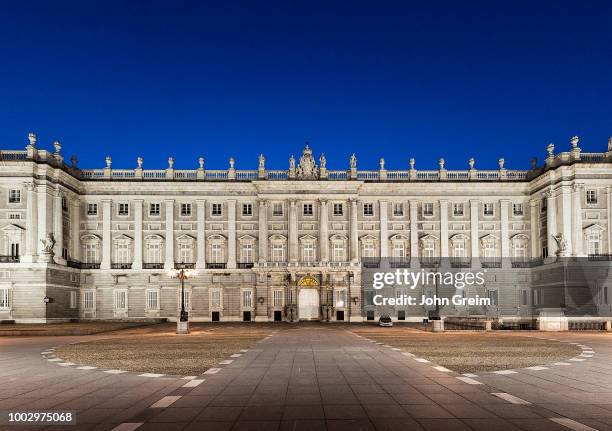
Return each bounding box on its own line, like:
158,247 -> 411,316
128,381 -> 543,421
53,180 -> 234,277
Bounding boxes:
0,1 -> 612,169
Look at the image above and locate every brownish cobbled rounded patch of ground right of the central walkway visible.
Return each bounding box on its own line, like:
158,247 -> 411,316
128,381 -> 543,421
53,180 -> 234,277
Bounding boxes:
351,325 -> 581,373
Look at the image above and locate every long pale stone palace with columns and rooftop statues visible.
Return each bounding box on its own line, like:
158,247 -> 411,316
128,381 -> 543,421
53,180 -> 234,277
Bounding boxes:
0,134 -> 612,322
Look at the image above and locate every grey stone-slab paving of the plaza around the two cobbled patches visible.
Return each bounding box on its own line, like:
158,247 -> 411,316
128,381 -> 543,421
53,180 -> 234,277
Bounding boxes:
0,324 -> 612,431
